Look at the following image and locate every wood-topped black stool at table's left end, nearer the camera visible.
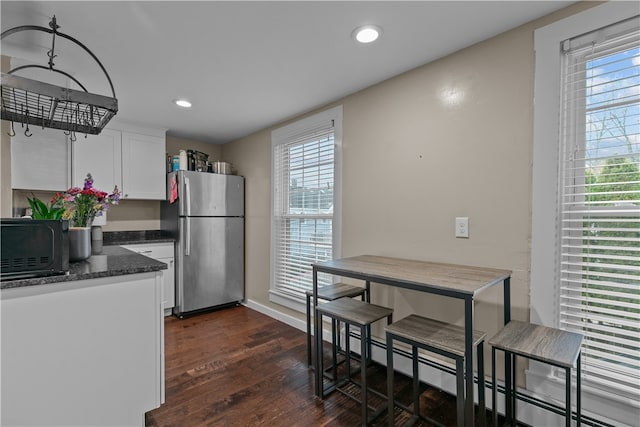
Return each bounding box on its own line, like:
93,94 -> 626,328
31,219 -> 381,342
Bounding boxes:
316,298 -> 393,426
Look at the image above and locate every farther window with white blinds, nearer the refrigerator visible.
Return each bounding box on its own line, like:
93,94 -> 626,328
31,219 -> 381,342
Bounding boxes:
271,107 -> 337,300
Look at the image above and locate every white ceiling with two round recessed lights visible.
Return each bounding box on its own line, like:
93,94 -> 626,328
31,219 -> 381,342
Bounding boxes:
0,0 -> 574,143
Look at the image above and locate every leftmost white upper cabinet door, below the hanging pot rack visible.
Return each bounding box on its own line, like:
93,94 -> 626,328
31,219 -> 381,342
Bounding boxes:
11,124 -> 71,191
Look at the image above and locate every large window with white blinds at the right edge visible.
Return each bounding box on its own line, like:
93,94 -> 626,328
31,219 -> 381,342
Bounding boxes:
557,17 -> 640,398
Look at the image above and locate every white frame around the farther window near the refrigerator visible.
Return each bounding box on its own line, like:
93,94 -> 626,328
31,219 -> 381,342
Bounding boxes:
269,105 -> 342,313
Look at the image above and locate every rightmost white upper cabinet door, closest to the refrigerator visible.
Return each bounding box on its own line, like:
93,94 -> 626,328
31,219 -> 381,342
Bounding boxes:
122,132 -> 167,200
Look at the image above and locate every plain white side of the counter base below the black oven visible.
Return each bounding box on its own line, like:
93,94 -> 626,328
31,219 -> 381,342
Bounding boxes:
0,272 -> 164,426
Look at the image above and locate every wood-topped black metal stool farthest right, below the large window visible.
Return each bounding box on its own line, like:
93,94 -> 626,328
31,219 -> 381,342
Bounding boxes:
489,320 -> 584,427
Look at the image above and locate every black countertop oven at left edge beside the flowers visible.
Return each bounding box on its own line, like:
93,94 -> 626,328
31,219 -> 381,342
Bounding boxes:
0,218 -> 69,280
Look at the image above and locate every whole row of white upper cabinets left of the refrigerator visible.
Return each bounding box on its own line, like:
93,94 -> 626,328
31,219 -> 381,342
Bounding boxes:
11,124 -> 167,200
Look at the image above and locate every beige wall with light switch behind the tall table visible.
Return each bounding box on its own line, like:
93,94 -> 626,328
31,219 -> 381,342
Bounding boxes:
222,3 -> 597,380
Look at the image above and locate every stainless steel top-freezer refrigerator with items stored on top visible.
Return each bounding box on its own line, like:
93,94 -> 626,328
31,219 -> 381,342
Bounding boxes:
160,170 -> 244,317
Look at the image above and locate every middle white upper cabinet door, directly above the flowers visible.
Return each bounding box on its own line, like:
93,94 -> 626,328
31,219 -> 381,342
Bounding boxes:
72,129 -> 122,193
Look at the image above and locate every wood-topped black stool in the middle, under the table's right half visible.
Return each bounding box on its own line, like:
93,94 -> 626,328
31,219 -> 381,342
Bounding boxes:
386,314 -> 486,426
